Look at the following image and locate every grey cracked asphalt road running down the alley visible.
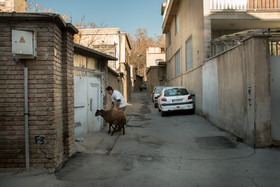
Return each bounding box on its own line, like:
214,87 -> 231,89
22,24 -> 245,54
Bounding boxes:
0,92 -> 280,187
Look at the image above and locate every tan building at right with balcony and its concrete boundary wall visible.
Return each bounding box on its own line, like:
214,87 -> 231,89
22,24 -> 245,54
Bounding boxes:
162,0 -> 280,147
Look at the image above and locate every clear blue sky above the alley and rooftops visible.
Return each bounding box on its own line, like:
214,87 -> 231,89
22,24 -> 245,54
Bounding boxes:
30,0 -> 166,37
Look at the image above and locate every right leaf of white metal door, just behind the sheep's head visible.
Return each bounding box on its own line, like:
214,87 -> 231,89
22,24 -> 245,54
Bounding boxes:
88,77 -> 101,132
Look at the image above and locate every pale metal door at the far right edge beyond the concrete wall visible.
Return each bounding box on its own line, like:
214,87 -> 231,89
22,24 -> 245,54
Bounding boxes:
270,56 -> 280,141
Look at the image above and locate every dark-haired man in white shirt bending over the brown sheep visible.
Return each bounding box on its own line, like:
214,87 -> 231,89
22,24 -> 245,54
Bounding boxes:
106,86 -> 126,112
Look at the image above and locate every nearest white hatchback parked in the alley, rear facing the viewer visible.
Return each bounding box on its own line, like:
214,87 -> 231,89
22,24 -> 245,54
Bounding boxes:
158,86 -> 194,116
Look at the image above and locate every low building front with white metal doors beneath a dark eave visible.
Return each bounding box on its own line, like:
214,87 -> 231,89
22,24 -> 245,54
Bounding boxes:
74,44 -> 119,139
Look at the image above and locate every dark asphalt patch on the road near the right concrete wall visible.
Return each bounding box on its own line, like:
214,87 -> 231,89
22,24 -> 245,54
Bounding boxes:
195,136 -> 237,149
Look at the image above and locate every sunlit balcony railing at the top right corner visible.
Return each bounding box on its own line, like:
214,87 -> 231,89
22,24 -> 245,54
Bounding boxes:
210,0 -> 280,11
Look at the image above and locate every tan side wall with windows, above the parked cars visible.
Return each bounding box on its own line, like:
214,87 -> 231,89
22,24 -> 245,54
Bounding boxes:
163,0 -> 203,114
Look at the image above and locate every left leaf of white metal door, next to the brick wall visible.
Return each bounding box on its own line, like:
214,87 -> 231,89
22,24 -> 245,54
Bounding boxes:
74,76 -> 88,137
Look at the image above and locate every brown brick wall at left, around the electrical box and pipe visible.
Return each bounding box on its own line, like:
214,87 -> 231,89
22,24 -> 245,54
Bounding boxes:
0,14 -> 76,168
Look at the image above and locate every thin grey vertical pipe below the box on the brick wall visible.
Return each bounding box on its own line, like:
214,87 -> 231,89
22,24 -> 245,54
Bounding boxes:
24,62 -> 30,171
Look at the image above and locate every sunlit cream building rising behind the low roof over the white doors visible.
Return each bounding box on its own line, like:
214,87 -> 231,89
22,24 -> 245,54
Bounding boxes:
75,28 -> 131,101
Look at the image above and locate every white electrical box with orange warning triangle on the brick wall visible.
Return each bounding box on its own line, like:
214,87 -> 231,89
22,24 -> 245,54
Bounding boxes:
12,30 -> 37,59
